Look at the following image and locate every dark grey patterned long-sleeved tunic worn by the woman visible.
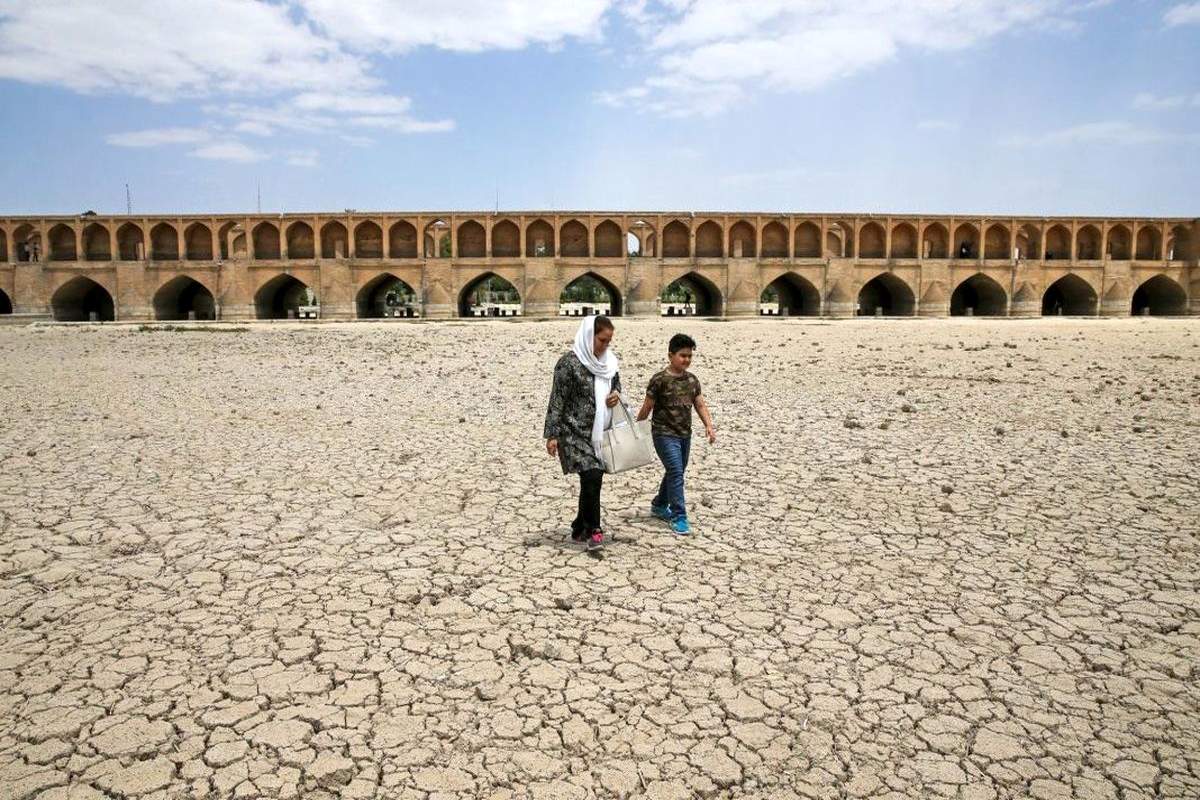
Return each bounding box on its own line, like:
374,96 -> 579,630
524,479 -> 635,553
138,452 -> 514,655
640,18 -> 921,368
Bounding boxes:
542,353 -> 620,473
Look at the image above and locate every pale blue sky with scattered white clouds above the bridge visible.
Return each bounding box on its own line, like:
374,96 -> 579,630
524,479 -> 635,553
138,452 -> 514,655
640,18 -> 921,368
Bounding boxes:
0,0 -> 1200,217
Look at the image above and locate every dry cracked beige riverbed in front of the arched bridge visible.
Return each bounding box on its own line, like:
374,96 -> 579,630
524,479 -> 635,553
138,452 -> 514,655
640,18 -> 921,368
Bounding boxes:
0,319 -> 1200,800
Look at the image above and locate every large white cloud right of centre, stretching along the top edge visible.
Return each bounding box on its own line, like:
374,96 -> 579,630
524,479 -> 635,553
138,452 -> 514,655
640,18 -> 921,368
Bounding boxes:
614,0 -> 1096,115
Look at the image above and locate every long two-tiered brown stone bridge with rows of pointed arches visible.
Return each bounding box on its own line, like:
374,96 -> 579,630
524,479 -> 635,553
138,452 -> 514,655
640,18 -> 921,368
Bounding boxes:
0,211 -> 1200,320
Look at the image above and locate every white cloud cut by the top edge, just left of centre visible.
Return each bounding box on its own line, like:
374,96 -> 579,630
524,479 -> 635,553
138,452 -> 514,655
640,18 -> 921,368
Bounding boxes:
296,0 -> 610,53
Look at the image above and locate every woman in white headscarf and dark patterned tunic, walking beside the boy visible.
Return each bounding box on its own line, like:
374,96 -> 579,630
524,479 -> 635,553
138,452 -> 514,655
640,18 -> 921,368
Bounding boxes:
542,317 -> 620,551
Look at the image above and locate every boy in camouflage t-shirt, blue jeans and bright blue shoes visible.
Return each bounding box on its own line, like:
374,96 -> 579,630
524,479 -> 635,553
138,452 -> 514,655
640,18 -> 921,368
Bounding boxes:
637,333 -> 716,535
